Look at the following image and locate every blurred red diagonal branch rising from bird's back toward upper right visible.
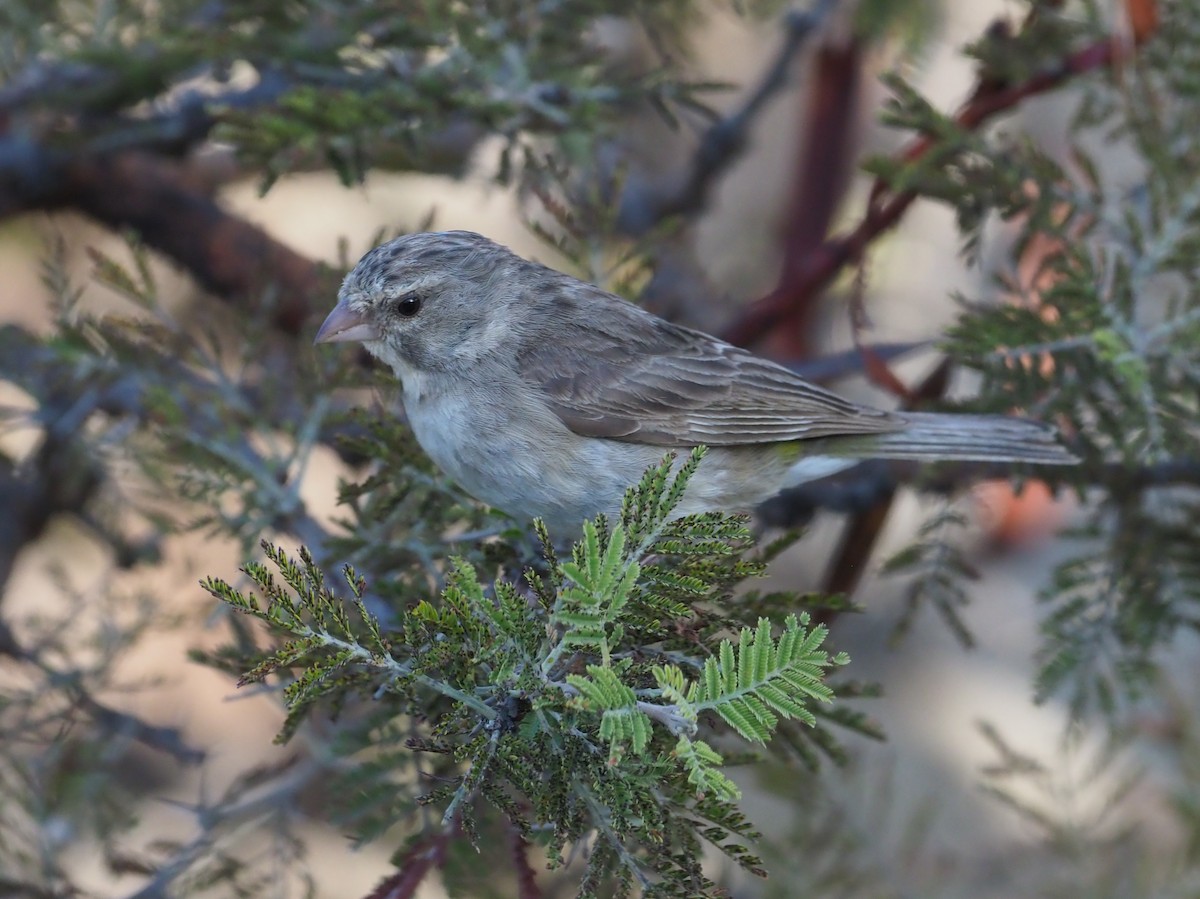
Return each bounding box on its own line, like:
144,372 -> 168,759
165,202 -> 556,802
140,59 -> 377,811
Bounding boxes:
724,29 -> 1129,346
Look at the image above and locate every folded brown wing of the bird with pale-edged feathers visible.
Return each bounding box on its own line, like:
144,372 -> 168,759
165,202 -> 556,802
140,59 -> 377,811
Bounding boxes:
517,286 -> 904,446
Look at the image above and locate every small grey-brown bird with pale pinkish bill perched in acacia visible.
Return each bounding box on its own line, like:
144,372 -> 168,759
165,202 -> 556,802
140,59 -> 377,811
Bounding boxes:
316,230 -> 1076,533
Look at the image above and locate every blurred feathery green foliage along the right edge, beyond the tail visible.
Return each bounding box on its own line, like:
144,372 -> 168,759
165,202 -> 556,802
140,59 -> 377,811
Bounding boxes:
874,2 -> 1200,715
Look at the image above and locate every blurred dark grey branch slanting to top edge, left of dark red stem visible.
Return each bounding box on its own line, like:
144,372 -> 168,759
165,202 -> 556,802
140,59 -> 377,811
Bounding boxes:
619,0 -> 838,235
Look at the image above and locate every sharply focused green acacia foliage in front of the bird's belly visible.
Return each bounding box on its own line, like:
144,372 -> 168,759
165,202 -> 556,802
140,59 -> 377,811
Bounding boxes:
204,450 -> 848,895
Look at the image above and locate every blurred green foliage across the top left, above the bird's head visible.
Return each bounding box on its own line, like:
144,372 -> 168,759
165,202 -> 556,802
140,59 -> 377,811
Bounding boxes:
0,0 -> 707,190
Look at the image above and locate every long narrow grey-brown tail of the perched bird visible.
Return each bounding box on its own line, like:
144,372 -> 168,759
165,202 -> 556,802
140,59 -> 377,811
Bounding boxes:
871,412 -> 1079,465
